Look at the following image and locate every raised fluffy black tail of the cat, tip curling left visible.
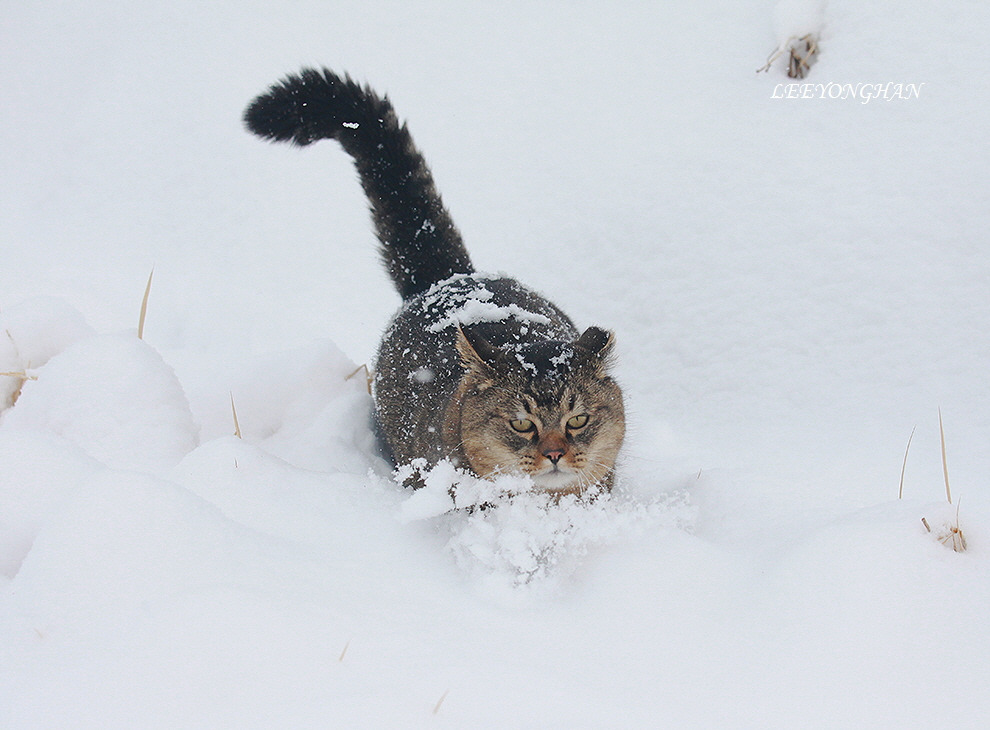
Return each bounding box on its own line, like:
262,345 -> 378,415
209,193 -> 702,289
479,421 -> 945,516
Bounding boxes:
244,69 -> 474,299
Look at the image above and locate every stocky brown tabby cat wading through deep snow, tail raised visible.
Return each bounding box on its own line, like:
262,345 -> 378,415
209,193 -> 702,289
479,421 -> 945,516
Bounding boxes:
244,69 -> 625,494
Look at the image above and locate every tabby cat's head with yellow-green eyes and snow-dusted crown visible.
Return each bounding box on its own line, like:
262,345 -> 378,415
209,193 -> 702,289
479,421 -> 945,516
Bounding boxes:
454,327 -> 625,493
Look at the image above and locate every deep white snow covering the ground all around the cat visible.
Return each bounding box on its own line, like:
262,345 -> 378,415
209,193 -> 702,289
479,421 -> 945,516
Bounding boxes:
0,0 -> 990,729
